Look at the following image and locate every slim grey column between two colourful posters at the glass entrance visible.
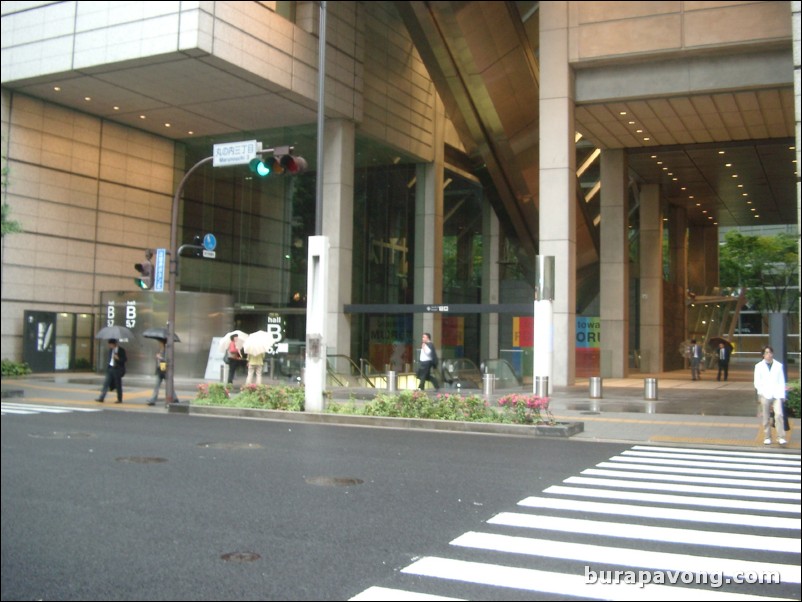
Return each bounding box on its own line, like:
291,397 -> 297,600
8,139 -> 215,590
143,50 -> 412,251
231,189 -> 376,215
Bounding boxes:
479,203 -> 501,359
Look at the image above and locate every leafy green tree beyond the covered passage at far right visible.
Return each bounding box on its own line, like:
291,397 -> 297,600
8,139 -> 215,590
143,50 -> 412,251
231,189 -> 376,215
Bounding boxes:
719,230 -> 799,314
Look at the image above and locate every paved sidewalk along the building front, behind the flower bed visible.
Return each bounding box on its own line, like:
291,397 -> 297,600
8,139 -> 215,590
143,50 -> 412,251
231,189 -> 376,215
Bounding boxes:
1,372 -> 800,453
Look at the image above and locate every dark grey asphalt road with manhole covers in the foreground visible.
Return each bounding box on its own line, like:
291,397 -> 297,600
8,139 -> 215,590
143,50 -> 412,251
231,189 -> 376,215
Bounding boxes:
1,410 -> 800,600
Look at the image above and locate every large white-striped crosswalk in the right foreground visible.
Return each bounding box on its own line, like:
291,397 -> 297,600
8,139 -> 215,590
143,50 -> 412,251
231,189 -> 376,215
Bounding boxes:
351,445 -> 802,601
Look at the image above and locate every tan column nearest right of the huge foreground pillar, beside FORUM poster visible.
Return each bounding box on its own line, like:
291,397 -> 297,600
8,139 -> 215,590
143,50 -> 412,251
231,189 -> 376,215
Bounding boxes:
599,149 -> 629,378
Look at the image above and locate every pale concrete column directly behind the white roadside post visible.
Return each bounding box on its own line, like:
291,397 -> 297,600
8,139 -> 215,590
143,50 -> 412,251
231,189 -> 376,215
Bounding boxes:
322,119 -> 355,355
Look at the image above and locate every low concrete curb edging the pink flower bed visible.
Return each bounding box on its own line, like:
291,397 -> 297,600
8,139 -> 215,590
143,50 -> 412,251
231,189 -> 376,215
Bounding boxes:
189,404 -> 585,437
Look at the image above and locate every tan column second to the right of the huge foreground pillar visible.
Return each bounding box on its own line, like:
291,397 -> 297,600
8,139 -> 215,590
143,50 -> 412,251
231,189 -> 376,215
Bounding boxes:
640,184 -> 663,373
